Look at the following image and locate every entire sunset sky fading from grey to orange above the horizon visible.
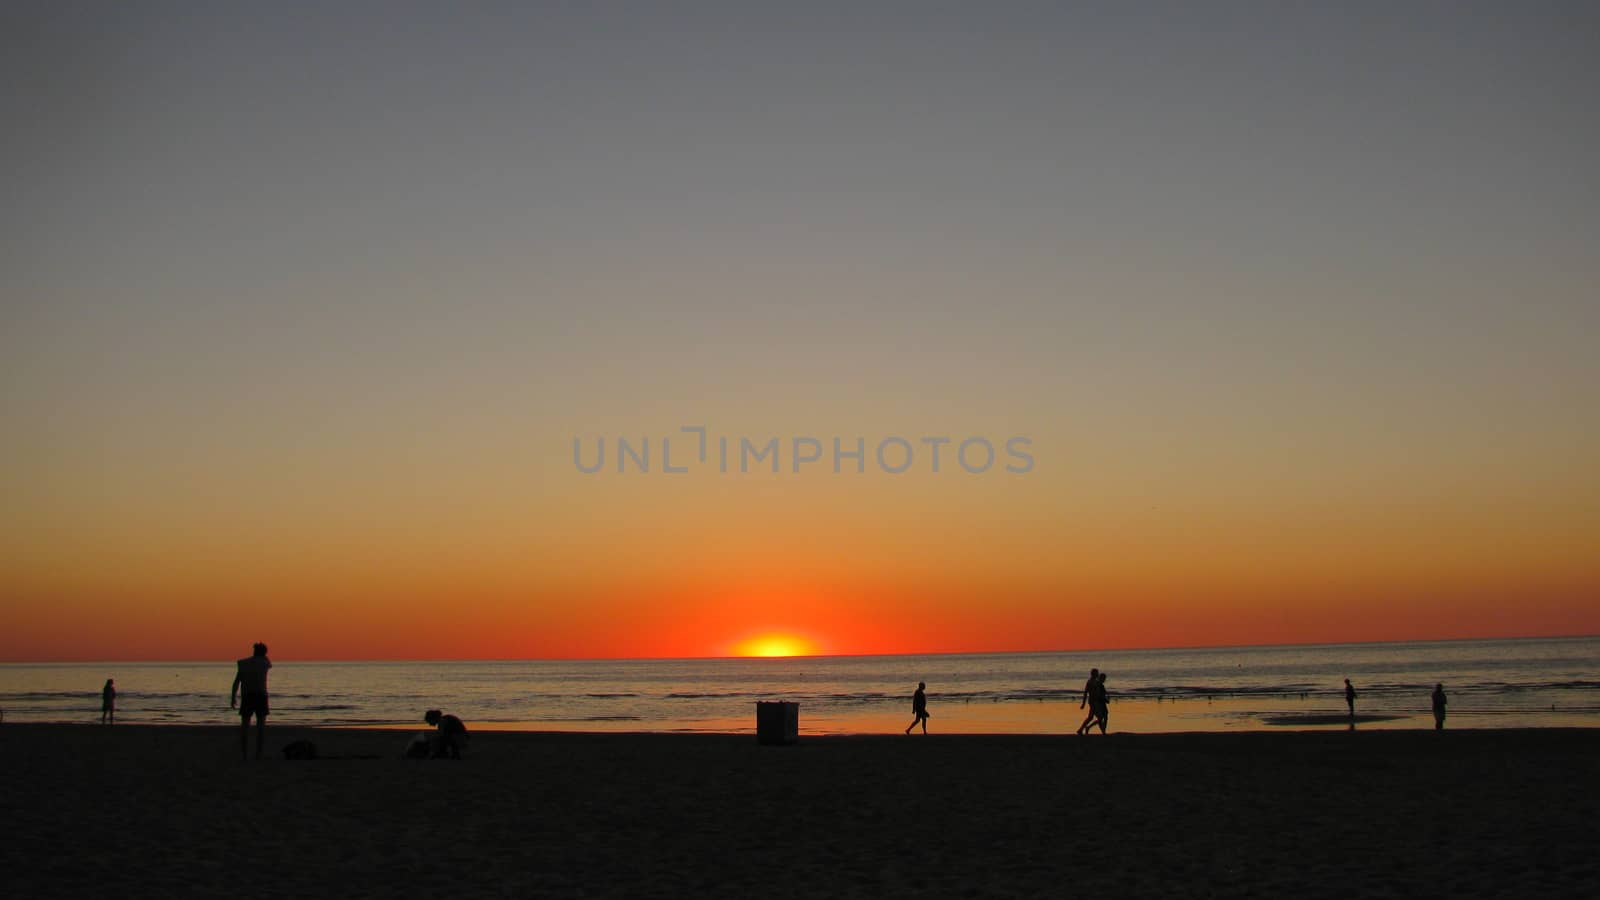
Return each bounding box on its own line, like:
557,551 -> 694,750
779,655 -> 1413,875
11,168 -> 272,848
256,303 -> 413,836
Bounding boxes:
0,2 -> 1600,660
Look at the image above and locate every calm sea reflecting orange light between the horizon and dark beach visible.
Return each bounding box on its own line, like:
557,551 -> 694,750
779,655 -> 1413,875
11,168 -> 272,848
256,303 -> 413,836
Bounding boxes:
0,637 -> 1600,733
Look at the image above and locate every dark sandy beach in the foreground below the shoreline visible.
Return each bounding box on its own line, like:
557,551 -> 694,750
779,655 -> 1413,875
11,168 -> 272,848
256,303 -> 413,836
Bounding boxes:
0,724 -> 1600,898
